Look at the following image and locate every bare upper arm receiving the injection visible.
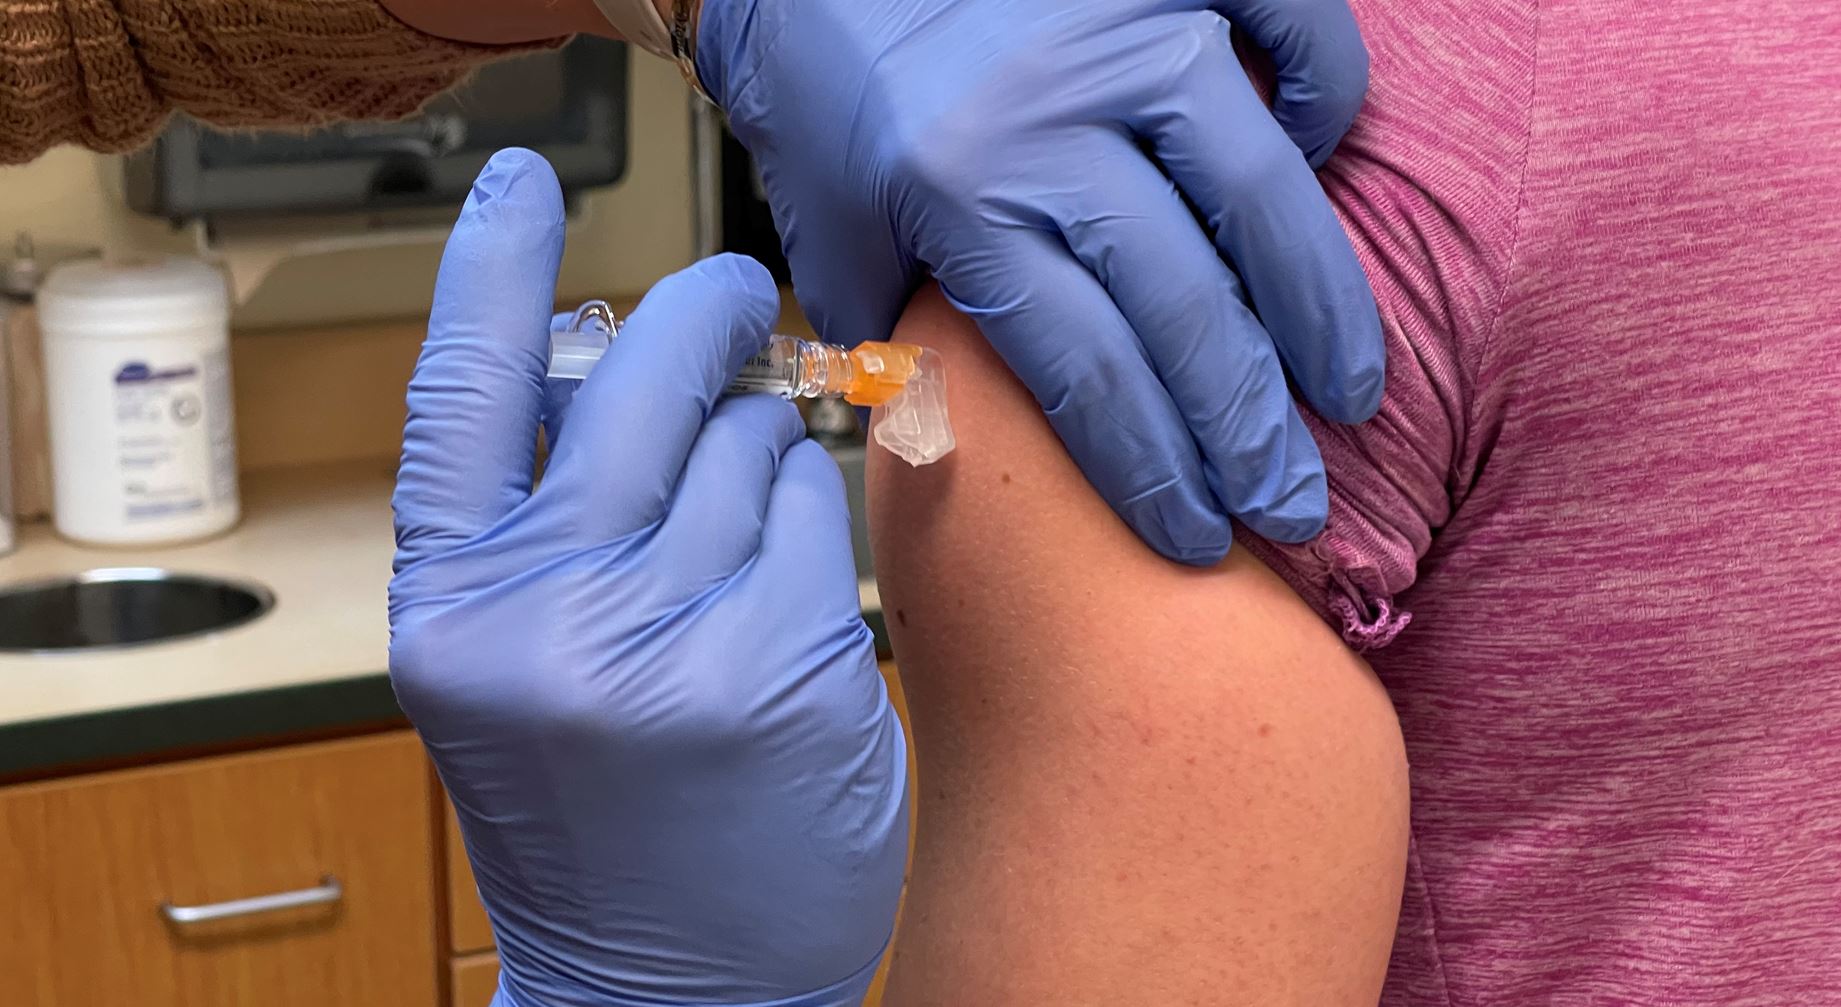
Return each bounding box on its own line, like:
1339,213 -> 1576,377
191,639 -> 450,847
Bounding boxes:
869,287 -> 1407,1007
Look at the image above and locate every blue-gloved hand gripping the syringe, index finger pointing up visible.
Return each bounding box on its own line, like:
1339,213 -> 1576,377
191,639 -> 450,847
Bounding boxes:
390,151 -> 908,1007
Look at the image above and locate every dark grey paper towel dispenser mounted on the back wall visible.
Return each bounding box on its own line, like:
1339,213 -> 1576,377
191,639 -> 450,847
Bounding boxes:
125,37 -> 628,223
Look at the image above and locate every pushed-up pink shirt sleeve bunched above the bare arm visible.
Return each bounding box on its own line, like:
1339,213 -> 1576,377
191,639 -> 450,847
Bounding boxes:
1239,0 -> 1535,650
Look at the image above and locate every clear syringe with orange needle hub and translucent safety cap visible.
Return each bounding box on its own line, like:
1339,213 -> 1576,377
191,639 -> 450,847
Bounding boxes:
549,300 -> 954,466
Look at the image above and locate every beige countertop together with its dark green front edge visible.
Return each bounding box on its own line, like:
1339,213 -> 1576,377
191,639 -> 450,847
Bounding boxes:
0,462 -> 886,781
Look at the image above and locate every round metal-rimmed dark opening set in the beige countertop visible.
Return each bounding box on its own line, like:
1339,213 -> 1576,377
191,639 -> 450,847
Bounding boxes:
0,567 -> 274,654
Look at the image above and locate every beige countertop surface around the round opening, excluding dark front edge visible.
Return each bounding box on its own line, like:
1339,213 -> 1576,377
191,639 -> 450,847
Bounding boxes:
0,462 -> 396,727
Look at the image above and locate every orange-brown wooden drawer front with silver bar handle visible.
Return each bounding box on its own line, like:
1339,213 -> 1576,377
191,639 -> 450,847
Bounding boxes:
0,731 -> 438,1007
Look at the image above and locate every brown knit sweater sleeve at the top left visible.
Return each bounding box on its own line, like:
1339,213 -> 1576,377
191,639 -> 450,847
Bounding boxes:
0,0 -> 562,164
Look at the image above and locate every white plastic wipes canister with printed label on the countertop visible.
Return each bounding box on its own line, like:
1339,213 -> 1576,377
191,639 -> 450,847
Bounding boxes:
39,258 -> 237,545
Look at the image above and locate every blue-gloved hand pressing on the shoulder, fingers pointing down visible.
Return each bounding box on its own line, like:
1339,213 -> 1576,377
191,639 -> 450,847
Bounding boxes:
698,0 -> 1384,563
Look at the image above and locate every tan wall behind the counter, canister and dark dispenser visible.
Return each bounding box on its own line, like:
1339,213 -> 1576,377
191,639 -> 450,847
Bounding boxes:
0,53 -> 714,486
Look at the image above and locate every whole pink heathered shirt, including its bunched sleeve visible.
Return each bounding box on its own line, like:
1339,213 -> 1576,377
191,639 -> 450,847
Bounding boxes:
1243,0 -> 1841,1007
